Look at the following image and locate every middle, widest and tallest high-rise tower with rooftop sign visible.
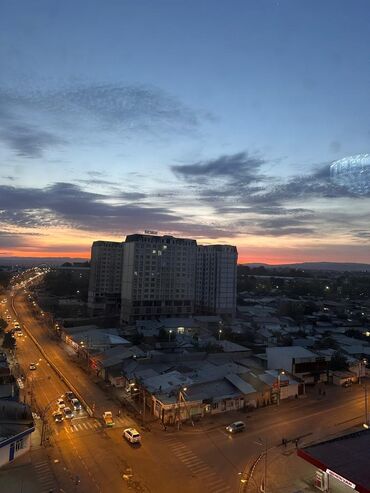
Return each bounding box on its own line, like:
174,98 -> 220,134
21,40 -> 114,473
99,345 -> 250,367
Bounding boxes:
121,234 -> 197,322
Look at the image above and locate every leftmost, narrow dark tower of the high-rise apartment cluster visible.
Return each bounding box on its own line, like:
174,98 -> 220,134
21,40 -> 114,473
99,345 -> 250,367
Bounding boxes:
88,241 -> 123,314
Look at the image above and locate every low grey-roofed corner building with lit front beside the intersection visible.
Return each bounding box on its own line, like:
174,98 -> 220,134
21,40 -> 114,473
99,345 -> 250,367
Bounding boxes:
118,353 -> 271,424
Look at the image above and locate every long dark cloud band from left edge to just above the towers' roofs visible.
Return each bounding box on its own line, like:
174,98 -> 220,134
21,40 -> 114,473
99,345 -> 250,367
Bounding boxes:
0,183 -> 230,238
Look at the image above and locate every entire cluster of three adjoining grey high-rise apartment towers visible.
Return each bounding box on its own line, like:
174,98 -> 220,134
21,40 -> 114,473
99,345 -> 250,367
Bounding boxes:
88,234 -> 238,323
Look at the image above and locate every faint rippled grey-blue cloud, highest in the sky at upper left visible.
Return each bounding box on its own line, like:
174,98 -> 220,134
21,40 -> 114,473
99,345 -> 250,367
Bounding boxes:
0,84 -> 205,158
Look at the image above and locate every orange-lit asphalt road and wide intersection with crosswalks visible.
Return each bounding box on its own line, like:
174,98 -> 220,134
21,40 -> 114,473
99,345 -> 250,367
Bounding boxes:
2,280 -> 364,493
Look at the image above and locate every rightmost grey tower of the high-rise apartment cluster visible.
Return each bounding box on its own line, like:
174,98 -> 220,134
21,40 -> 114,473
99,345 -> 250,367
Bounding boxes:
195,245 -> 238,317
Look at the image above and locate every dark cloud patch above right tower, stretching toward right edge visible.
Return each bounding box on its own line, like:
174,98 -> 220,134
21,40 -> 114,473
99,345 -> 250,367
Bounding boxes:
186,153 -> 370,210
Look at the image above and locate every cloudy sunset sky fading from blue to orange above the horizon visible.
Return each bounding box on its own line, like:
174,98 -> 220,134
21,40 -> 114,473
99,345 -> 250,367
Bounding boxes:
0,0 -> 370,263
